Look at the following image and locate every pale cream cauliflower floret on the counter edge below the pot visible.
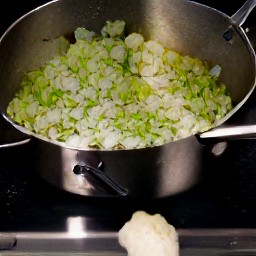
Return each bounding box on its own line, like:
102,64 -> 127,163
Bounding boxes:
118,211 -> 179,256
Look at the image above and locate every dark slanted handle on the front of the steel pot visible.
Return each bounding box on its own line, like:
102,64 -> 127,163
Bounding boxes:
73,162 -> 128,196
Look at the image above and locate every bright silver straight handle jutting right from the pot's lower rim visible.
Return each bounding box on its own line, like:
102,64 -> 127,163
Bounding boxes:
198,124 -> 256,139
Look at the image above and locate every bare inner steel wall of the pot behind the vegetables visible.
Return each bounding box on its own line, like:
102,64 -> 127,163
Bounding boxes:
0,0 -> 255,127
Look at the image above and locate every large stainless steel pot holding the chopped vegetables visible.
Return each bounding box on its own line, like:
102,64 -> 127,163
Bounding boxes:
0,0 -> 256,197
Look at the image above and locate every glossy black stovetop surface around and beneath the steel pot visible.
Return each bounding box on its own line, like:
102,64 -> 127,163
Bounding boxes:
0,0 -> 256,236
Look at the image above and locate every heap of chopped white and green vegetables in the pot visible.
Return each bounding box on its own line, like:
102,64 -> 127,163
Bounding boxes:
7,20 -> 232,149
